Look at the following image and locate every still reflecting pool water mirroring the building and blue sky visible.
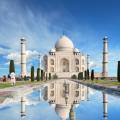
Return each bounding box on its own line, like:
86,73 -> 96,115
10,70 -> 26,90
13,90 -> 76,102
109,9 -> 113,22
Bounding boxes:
0,80 -> 120,120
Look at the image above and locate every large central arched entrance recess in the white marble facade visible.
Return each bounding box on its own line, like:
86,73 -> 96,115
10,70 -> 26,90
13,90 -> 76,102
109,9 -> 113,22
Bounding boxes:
60,58 -> 69,72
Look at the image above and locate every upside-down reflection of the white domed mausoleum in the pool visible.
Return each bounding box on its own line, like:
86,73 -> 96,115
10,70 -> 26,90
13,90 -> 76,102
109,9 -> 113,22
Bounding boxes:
44,80 -> 88,120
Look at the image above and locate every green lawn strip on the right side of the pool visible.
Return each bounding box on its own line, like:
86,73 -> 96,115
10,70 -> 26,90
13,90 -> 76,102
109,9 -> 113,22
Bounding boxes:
83,80 -> 120,86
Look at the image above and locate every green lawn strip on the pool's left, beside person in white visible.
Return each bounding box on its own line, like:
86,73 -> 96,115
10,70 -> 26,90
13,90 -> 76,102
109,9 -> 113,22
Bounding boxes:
0,81 -> 45,89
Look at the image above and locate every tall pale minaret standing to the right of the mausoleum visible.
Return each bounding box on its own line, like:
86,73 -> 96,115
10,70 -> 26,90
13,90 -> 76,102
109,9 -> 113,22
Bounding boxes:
102,36 -> 108,78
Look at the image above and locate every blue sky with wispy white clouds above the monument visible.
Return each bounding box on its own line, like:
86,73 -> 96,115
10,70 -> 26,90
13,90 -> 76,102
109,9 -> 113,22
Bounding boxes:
0,0 -> 120,76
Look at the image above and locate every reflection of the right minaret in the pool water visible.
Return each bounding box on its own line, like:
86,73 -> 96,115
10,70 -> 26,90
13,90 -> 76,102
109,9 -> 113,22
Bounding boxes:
103,92 -> 108,120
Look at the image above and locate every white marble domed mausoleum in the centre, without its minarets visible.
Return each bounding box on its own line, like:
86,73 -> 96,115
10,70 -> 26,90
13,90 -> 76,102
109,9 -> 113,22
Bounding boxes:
44,35 -> 86,78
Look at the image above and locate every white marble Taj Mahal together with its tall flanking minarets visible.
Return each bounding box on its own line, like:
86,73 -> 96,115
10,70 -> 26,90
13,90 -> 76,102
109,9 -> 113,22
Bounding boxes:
21,35 -> 108,78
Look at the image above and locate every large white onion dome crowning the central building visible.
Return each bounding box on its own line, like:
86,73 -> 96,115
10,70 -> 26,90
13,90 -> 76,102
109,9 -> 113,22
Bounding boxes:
55,35 -> 74,51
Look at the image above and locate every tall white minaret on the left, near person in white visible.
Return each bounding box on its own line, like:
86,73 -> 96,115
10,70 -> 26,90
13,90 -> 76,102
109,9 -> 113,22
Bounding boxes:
21,38 -> 26,78
